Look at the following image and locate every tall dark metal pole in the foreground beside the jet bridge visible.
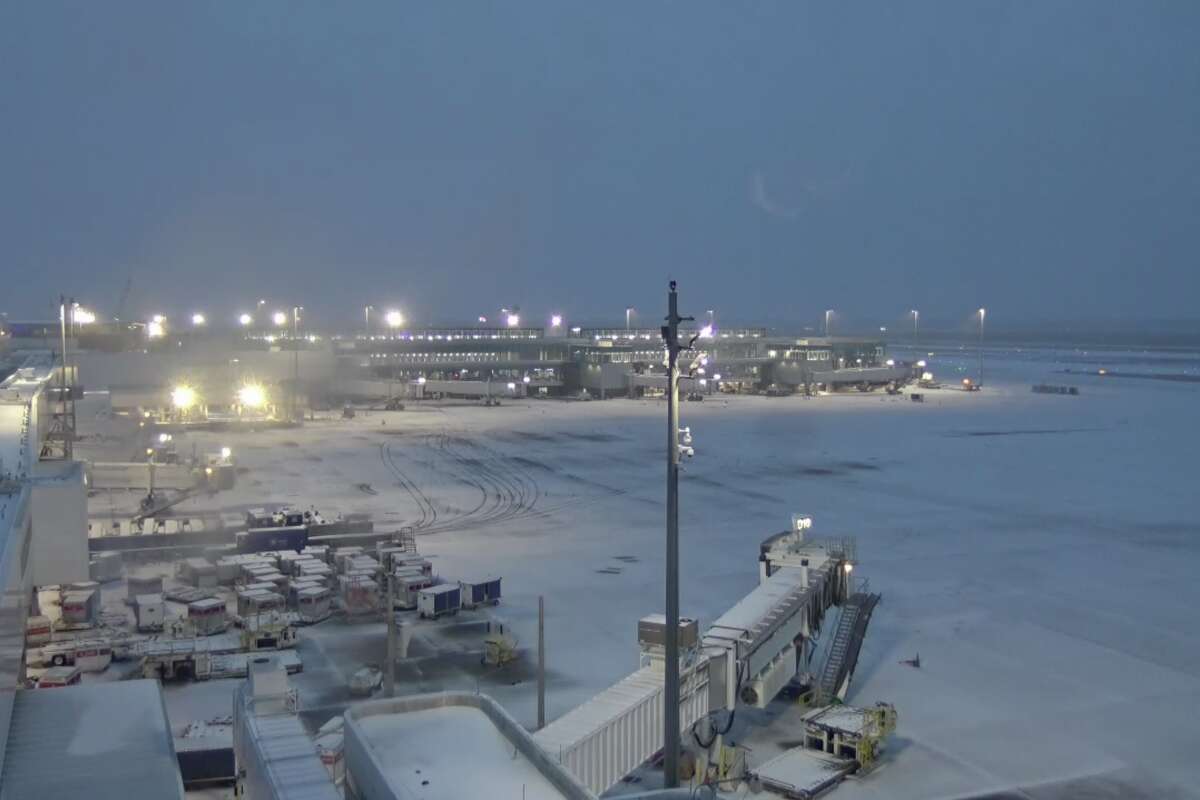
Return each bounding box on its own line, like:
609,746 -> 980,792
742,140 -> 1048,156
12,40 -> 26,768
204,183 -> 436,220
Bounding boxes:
662,281 -> 692,789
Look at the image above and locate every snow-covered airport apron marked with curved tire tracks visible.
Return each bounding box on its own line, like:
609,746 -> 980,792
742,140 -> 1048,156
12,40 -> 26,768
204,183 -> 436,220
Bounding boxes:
84,349 -> 1200,798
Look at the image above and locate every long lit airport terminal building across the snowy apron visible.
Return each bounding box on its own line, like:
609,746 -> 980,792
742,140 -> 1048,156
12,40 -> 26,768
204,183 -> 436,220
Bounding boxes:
7,324 -> 912,417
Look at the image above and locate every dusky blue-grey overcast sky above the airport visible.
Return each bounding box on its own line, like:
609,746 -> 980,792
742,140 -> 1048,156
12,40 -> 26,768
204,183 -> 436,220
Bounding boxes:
0,0 -> 1200,324
